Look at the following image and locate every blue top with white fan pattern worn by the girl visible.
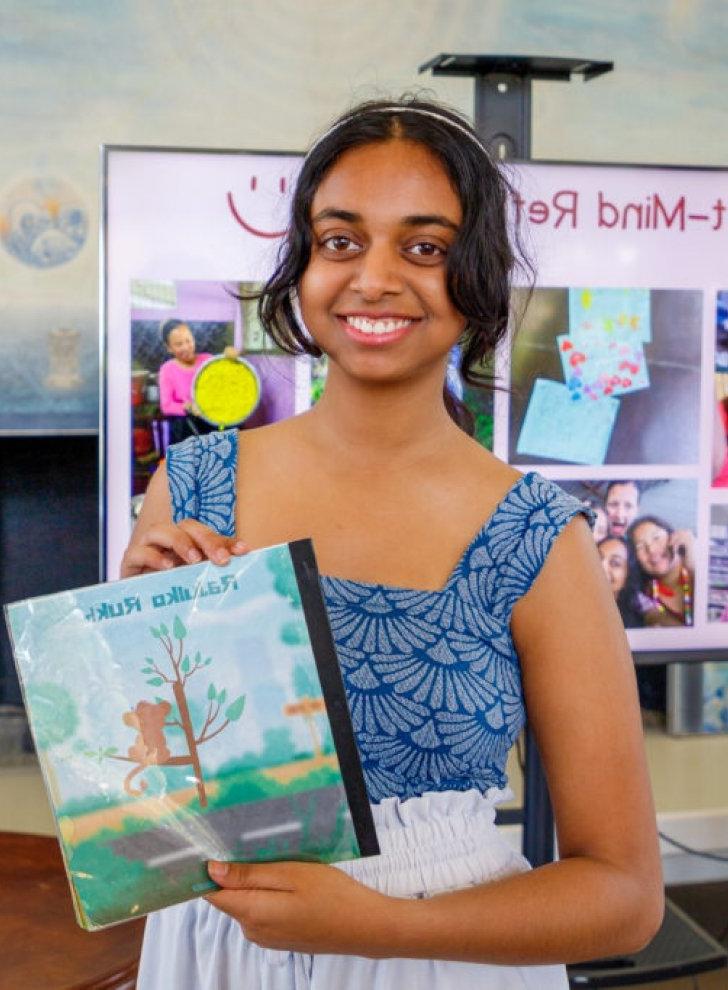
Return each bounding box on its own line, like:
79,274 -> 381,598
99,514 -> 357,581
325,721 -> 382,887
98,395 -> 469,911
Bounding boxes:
167,430 -> 588,803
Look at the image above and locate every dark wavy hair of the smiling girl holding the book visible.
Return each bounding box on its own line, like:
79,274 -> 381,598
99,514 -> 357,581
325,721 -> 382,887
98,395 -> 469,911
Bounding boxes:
250,97 -> 533,433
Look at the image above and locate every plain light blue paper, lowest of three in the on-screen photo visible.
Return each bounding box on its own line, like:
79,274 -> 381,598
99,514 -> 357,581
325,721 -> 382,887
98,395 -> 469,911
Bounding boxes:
516,378 -> 619,464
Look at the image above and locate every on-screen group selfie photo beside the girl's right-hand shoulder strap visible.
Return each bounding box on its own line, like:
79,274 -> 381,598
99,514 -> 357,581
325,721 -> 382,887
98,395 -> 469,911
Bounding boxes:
562,479 -> 697,628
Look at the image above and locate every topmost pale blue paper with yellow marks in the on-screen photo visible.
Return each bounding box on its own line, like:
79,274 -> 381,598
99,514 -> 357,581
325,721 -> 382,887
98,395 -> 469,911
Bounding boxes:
569,288 -> 652,343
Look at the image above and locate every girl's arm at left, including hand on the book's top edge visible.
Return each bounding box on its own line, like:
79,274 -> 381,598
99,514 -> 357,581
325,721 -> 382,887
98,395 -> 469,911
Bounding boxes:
120,463 -> 247,578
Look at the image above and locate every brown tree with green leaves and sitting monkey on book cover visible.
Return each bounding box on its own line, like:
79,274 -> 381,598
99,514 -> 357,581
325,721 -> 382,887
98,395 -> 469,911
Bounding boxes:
108,616 -> 245,808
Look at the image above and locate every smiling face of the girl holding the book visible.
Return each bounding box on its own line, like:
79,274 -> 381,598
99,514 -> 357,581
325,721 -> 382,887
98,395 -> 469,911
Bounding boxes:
299,140 -> 465,382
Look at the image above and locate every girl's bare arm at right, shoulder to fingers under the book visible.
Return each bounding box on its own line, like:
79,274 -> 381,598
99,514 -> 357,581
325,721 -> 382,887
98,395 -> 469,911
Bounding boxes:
209,519 -> 663,965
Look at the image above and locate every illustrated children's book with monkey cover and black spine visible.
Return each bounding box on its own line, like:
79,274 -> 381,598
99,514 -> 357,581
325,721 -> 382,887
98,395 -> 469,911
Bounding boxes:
6,540 -> 379,930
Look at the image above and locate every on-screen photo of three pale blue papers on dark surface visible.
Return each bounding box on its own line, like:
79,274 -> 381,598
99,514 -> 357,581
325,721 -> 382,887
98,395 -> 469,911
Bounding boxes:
510,283 -> 712,469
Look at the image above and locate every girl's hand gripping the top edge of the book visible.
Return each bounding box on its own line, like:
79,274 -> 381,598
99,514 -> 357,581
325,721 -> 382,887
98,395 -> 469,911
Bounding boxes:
120,519 -> 248,578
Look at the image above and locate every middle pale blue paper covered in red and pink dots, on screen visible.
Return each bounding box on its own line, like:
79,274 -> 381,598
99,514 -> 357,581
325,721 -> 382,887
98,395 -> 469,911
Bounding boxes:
556,334 -> 650,399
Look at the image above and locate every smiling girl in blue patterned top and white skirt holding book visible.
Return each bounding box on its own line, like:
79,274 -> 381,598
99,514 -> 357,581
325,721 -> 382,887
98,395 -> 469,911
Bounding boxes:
123,100 -> 662,990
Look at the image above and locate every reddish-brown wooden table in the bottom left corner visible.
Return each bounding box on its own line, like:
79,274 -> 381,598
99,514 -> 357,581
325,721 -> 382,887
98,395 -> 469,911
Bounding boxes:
0,832 -> 144,990
